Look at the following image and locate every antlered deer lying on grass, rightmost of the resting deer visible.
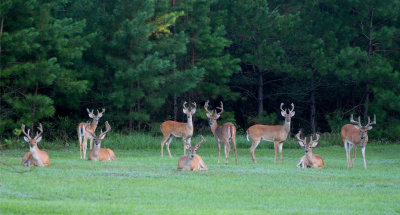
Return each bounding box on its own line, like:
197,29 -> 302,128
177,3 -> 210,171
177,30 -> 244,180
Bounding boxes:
296,130 -> 324,169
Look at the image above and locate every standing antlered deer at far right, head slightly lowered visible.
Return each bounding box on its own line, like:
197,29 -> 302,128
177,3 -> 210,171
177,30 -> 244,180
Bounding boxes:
340,114 -> 376,169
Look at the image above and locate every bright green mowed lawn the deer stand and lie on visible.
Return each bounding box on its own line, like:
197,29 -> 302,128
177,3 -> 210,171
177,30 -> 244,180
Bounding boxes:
0,142 -> 400,214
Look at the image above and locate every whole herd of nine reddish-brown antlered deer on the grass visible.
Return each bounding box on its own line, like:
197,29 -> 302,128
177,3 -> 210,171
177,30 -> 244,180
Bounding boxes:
21,101 -> 376,170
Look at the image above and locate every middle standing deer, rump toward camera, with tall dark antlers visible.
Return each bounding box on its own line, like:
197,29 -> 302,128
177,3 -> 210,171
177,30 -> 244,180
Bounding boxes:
204,101 -> 238,165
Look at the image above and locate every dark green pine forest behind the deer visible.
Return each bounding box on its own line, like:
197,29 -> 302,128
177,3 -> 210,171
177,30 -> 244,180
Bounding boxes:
0,0 -> 400,141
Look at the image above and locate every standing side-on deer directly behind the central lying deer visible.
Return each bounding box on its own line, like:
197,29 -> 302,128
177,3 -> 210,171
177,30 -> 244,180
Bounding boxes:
160,101 -> 196,158
